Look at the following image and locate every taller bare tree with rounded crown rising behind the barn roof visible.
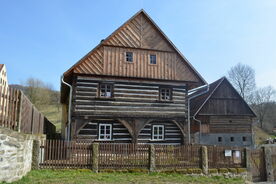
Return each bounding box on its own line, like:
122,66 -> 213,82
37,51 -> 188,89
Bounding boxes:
228,63 -> 256,101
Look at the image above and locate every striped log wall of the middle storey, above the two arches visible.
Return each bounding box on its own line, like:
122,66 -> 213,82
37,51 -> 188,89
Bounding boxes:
73,76 -> 187,118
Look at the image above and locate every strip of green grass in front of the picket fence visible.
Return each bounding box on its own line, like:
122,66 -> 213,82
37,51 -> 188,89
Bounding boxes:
5,170 -> 245,184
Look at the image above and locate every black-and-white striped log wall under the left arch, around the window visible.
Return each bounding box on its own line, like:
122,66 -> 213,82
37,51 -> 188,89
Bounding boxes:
77,121 -> 132,143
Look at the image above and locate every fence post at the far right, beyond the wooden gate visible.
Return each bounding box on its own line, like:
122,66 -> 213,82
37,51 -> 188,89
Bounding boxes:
264,146 -> 274,182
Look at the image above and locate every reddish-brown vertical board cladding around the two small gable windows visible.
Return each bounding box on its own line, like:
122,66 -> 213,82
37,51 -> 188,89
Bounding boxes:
104,46 -> 198,82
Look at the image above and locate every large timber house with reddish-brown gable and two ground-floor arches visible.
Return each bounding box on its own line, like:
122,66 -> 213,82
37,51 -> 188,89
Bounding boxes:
61,10 -> 206,144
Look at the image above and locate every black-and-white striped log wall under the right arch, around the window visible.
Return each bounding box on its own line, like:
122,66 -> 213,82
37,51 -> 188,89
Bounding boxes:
138,121 -> 183,144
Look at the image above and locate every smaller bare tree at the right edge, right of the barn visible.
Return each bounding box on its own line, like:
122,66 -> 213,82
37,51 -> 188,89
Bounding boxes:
252,86 -> 275,128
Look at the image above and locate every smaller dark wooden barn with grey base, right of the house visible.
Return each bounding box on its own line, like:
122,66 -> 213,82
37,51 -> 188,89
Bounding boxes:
189,77 -> 256,146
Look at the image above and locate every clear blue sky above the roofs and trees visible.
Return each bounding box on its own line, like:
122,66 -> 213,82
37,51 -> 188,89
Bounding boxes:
0,0 -> 276,89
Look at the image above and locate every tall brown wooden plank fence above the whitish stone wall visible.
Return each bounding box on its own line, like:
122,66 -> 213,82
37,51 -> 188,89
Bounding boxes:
0,85 -> 55,134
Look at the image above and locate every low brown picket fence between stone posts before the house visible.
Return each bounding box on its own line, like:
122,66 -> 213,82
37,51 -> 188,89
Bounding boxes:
40,140 -> 245,170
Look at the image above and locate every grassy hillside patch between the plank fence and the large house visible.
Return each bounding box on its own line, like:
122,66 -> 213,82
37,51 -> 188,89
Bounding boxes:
39,105 -> 61,132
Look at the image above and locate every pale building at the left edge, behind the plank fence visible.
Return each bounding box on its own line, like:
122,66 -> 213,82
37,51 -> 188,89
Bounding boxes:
0,64 -> 9,117
